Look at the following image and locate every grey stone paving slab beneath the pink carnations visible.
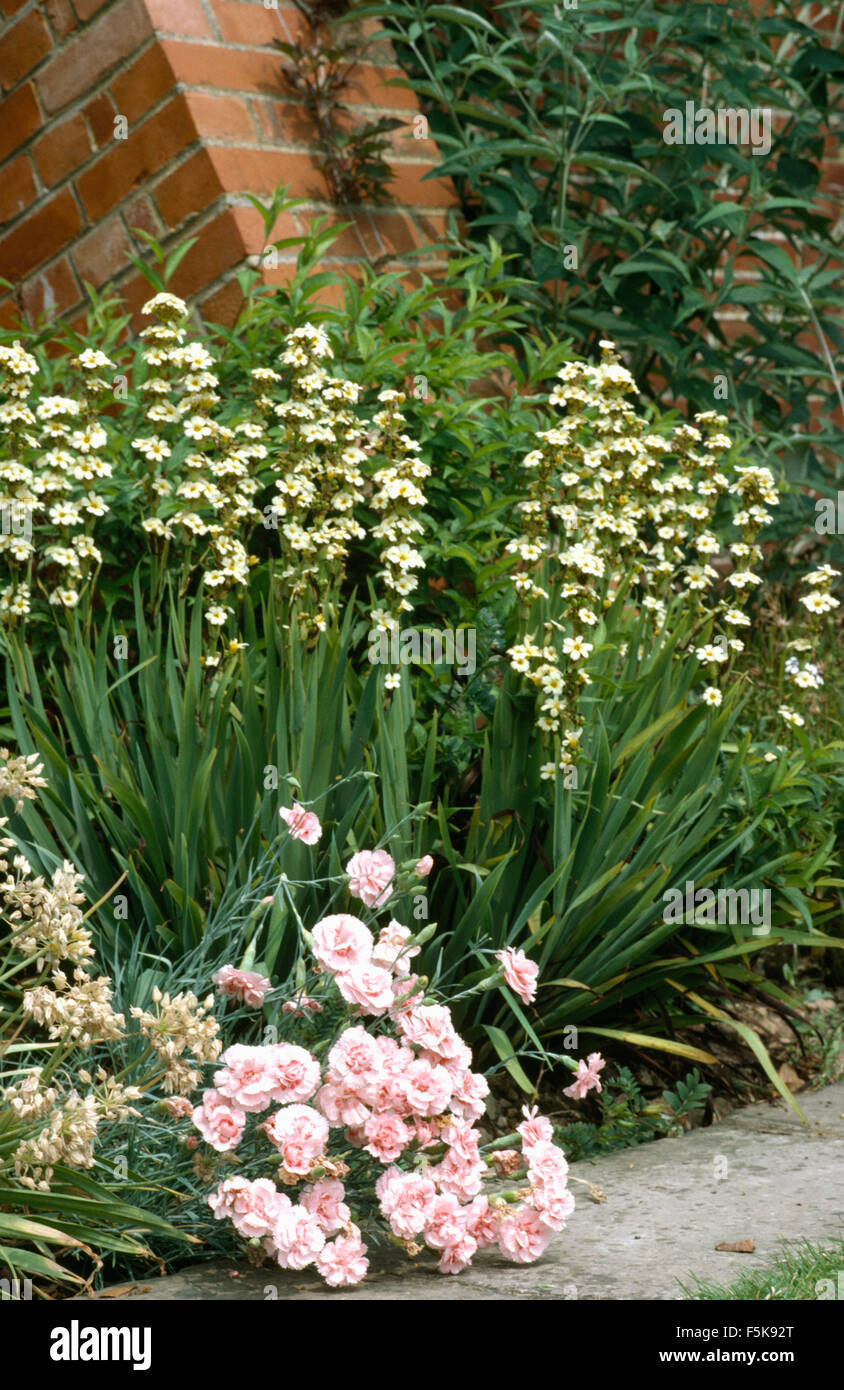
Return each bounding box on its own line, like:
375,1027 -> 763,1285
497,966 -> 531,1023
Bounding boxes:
79,1081 -> 844,1301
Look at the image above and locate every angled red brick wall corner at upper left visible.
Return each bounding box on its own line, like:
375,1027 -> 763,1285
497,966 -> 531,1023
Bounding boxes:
0,0 -> 453,322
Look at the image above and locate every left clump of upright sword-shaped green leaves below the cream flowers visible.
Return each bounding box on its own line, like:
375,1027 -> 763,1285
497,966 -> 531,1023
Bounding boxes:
1,589 -> 389,958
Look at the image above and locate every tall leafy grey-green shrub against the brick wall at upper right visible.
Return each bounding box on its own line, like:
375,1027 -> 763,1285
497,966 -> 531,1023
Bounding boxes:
360,0 -> 844,508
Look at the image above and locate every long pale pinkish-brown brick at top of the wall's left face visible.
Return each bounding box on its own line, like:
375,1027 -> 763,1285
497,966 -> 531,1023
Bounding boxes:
38,0 -> 152,114
